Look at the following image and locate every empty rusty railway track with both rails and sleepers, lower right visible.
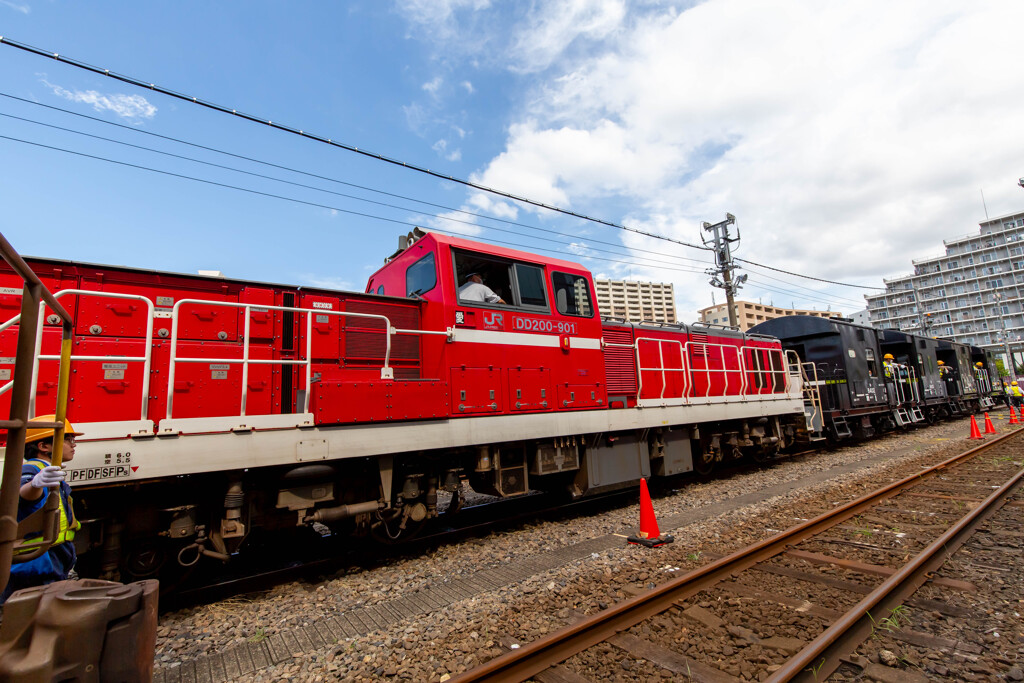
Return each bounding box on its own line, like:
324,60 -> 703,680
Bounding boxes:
452,423 -> 1024,683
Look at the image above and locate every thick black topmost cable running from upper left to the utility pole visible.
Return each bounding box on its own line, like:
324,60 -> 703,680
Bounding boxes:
0,36 -> 706,250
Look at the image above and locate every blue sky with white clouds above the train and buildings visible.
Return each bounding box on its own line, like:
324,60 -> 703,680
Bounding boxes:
0,0 -> 1024,321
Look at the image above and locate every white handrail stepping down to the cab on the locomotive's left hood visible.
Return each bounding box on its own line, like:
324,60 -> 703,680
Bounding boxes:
167,299 -> 452,420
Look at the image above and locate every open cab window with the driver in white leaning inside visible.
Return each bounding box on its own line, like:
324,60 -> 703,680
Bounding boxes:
453,251 -> 549,313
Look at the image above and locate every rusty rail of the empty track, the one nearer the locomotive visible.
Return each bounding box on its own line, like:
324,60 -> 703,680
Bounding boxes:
452,430 -> 1020,683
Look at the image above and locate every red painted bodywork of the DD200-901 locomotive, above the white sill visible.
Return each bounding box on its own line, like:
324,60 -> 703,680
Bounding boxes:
0,233 -> 785,424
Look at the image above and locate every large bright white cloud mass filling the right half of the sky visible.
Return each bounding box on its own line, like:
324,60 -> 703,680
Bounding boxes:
409,0 -> 1024,321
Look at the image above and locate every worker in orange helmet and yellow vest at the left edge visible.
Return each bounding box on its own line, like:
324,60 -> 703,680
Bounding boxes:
0,415 -> 82,604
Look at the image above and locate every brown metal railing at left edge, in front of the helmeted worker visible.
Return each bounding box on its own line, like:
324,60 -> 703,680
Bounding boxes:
0,234 -> 73,590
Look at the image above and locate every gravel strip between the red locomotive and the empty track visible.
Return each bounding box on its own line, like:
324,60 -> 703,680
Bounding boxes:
149,416 -> 1005,681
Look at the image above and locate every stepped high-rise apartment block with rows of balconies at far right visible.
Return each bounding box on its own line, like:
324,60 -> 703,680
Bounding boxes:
864,212 -> 1024,356
